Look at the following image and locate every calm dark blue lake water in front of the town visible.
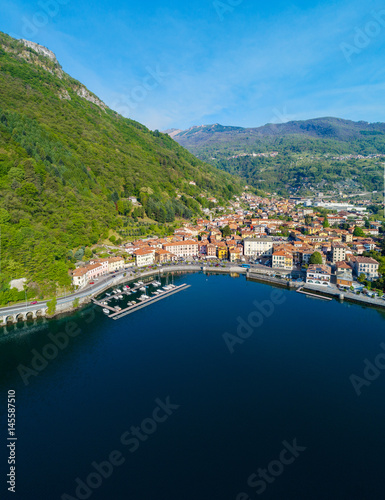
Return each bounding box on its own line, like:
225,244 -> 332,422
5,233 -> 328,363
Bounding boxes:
0,274 -> 385,500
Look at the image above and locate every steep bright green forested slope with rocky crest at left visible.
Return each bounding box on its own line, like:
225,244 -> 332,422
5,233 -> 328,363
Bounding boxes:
0,33 -> 240,300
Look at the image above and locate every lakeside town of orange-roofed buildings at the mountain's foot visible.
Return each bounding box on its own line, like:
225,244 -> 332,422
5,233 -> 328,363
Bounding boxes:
73,191 -> 383,289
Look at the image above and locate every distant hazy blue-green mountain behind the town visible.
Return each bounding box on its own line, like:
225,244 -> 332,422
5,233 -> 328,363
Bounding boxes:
170,118 -> 385,194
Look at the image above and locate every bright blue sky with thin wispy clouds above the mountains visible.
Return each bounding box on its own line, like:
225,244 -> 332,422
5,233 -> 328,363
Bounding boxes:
0,0 -> 385,130
